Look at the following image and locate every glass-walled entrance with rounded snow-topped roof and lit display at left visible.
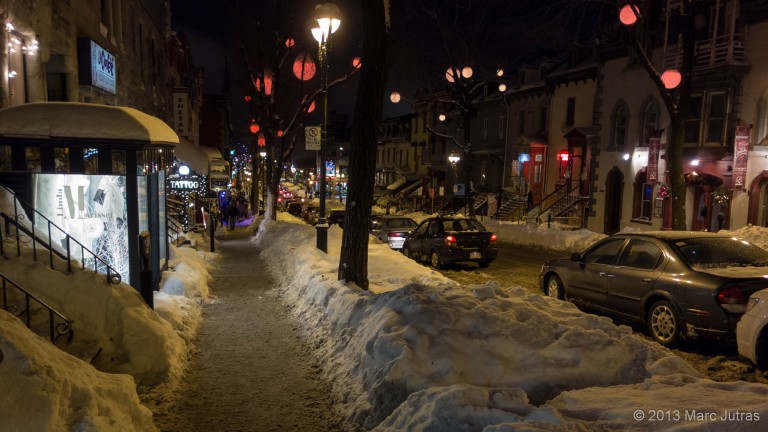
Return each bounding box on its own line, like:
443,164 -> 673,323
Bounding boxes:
0,102 -> 179,301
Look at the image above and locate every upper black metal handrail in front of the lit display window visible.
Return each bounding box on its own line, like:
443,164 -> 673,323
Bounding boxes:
0,188 -> 122,285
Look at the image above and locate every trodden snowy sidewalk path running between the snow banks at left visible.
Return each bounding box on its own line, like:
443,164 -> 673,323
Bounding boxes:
154,227 -> 333,432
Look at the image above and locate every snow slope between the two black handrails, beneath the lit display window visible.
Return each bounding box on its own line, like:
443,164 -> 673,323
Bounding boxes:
1,248 -> 184,384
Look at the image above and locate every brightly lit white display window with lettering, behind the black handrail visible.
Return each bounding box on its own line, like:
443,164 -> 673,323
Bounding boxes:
33,174 -> 130,283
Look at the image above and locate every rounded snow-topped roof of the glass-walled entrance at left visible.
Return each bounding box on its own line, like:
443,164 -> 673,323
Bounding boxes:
0,102 -> 179,145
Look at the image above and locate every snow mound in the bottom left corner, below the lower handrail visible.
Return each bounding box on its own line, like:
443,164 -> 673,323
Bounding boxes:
0,310 -> 155,431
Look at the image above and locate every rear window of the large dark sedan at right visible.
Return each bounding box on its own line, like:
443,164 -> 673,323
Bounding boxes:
675,238 -> 768,268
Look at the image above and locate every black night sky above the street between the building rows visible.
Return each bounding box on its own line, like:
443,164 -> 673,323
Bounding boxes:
171,0 -> 608,147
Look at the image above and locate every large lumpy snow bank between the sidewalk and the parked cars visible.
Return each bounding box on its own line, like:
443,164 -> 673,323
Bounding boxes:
255,215 -> 728,430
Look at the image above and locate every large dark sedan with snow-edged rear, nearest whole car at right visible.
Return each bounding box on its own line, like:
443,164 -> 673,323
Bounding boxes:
539,231 -> 768,346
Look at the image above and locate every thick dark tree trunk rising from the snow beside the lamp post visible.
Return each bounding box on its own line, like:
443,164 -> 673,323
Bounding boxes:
339,0 -> 389,290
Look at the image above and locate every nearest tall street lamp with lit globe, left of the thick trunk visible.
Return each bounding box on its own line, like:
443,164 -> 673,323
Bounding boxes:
312,3 -> 341,253
